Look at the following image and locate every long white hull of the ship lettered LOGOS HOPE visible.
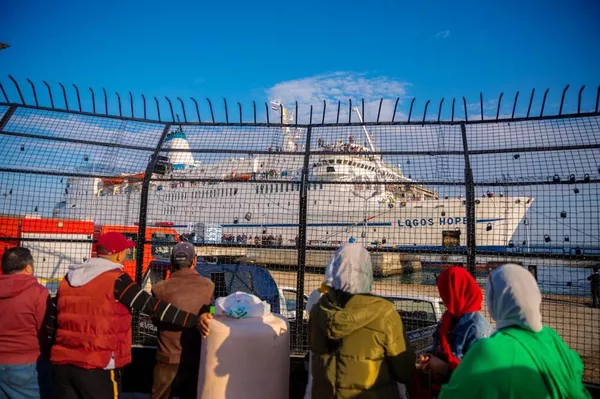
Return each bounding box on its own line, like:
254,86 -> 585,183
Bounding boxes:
63,182 -> 532,249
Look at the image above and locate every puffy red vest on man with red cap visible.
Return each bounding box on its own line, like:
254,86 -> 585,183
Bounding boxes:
50,270 -> 131,369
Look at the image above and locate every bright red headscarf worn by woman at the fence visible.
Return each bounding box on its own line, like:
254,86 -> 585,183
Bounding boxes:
437,266 -> 483,370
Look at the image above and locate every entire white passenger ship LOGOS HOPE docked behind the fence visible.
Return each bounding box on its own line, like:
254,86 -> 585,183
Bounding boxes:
55,104 -> 533,249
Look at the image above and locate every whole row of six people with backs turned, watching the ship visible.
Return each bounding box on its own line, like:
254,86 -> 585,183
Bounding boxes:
0,238 -> 590,399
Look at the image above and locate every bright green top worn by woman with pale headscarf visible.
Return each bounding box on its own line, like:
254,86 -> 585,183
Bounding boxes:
439,327 -> 590,399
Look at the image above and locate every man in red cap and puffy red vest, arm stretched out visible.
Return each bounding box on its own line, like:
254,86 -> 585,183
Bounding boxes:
50,233 -> 210,399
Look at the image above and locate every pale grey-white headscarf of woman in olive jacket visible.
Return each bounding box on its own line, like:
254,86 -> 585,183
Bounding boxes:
325,243 -> 373,294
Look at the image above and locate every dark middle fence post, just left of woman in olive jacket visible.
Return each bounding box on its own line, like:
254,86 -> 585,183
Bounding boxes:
294,126 -> 312,352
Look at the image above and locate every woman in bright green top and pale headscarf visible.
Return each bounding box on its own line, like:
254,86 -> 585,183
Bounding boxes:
439,264 -> 591,399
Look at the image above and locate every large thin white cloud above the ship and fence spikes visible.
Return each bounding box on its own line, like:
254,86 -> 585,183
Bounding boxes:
266,71 -> 410,122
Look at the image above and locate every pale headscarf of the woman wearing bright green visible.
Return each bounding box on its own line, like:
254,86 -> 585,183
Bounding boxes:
486,263 -> 542,332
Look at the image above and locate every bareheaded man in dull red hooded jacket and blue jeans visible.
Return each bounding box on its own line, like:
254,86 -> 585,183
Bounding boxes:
0,247 -> 55,398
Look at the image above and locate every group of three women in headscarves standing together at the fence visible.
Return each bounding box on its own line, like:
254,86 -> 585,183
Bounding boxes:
305,243 -> 591,399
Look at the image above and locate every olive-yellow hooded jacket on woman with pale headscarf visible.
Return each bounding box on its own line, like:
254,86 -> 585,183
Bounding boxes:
308,291 -> 415,399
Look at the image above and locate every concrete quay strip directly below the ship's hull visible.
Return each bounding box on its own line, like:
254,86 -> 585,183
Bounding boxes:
196,246 -> 421,277
